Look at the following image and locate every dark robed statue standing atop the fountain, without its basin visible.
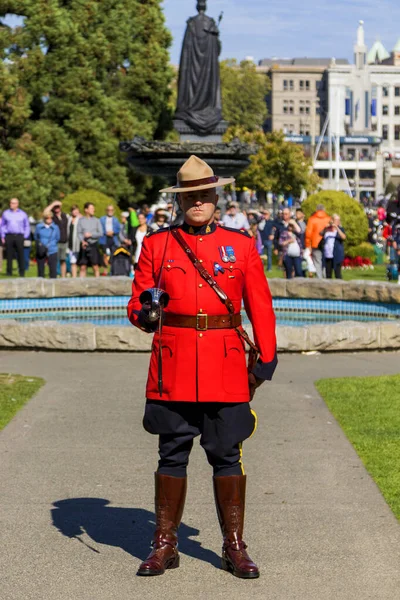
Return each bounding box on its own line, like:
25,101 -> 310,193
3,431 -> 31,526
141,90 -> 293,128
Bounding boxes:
175,0 -> 222,135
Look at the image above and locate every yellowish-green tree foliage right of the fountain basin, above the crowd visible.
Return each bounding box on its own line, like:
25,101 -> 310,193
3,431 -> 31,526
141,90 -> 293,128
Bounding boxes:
226,128 -> 320,198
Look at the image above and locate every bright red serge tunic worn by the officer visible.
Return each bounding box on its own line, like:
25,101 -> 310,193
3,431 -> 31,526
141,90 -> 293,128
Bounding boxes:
128,224 -> 277,402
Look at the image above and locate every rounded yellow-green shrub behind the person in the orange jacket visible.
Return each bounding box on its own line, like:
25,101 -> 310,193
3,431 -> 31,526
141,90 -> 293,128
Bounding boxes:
302,190 -> 368,253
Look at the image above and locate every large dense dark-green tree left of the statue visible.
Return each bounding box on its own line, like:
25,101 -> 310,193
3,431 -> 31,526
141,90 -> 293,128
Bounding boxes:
0,0 -> 172,210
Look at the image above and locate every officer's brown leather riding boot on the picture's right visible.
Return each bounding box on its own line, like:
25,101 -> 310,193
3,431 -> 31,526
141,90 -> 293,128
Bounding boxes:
214,475 -> 260,579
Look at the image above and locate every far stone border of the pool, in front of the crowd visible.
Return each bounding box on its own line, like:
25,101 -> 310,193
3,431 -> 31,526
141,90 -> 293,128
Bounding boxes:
0,277 -> 400,303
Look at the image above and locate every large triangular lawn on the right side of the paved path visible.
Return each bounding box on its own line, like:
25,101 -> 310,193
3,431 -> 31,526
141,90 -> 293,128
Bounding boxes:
316,375 -> 400,519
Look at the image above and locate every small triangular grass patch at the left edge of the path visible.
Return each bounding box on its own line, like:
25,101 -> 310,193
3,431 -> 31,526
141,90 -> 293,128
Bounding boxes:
0,373 -> 44,431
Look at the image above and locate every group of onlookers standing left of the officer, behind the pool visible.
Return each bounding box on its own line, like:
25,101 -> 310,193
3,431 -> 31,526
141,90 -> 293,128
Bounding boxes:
0,198 -> 172,278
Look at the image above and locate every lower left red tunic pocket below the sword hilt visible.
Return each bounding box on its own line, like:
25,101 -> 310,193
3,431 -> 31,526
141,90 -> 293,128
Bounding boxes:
146,333 -> 176,399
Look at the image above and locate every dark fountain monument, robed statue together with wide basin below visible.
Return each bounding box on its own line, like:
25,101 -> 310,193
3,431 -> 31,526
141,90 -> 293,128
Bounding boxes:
120,0 -> 252,183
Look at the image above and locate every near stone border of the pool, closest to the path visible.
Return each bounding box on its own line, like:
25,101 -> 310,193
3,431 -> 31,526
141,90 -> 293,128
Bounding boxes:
0,320 -> 400,352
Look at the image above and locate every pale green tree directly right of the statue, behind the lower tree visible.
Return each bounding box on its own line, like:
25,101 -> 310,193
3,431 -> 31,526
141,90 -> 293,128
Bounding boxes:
220,58 -> 270,131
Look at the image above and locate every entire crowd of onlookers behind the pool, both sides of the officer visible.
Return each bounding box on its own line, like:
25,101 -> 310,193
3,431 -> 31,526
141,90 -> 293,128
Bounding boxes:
0,188 -> 400,279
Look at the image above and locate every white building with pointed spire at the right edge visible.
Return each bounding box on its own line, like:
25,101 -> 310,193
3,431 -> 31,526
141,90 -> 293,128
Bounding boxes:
324,21 -> 400,196
